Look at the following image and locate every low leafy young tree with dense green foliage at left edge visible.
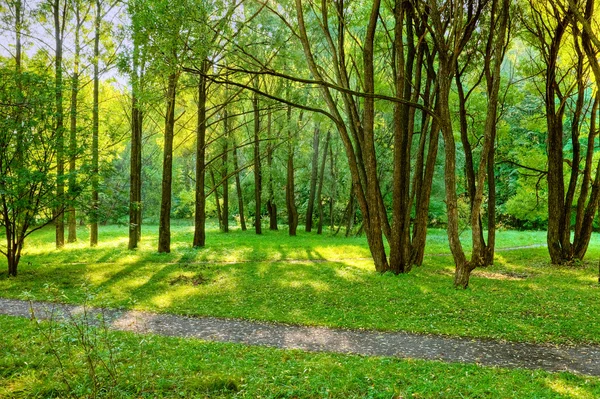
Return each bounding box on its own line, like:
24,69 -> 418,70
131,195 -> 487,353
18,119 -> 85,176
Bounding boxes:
0,67 -> 64,276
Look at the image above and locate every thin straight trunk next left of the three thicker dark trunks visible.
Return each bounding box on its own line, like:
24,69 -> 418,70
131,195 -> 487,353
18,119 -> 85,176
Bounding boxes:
90,0 -> 102,247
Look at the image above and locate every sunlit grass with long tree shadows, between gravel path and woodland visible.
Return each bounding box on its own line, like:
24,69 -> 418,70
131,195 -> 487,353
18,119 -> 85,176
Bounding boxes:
0,223 -> 600,344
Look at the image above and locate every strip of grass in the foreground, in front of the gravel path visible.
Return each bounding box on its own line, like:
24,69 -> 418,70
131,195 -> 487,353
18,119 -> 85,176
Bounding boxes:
0,316 -> 600,399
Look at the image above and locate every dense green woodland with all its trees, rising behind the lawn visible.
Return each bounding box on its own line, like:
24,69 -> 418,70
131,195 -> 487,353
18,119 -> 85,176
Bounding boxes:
0,0 -> 600,287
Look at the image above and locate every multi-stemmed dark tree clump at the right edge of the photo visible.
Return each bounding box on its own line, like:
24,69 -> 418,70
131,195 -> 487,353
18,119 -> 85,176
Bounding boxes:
526,1 -> 600,264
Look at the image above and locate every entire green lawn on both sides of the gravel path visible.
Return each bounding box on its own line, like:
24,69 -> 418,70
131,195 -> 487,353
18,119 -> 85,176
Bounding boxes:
0,223 -> 600,398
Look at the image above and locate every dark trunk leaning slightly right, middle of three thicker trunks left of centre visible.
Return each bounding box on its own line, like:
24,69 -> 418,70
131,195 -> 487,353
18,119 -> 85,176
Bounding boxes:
158,72 -> 179,252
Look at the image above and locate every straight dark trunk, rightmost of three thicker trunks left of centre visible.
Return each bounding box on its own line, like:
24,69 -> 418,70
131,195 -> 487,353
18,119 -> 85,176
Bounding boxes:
193,69 -> 210,248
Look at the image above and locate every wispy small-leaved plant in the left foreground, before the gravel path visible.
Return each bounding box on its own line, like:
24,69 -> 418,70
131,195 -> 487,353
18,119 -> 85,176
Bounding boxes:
28,286 -> 146,398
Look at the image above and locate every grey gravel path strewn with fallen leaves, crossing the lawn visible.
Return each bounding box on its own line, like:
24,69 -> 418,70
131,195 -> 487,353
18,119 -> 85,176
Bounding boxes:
0,299 -> 600,376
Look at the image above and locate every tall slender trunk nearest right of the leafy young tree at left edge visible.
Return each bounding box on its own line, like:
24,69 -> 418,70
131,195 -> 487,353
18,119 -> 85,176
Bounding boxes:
52,0 -> 65,248
